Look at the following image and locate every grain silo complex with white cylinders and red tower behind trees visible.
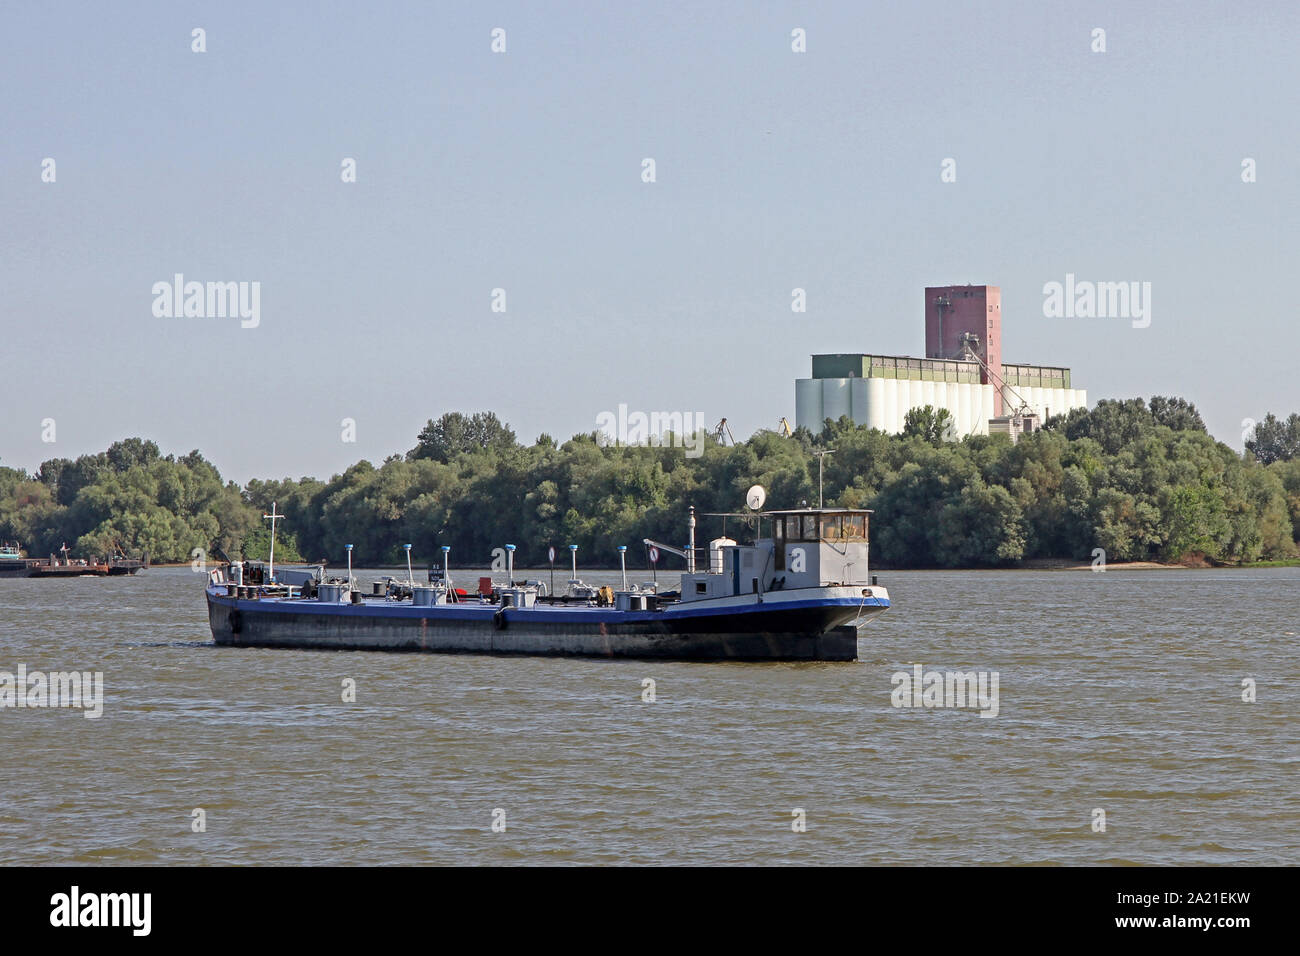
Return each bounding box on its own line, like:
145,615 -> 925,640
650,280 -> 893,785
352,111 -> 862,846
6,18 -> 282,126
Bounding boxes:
794,285 -> 1088,440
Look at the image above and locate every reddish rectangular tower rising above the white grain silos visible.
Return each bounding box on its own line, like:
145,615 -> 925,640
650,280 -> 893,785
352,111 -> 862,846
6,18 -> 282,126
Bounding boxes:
926,285 -> 1002,415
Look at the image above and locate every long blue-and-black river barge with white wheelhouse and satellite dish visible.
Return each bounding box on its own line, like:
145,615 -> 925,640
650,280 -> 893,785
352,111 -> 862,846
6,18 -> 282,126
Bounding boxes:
207,496 -> 889,661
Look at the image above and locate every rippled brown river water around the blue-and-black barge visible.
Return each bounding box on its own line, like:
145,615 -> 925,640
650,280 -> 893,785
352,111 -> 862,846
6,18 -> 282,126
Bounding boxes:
0,568 -> 1300,865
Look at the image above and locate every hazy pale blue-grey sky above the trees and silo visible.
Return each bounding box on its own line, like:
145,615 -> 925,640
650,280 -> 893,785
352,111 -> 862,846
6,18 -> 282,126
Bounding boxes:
0,0 -> 1300,483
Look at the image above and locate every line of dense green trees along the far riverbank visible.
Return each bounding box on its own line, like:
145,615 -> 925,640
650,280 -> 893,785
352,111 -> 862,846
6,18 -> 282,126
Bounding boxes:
0,397 -> 1300,567
